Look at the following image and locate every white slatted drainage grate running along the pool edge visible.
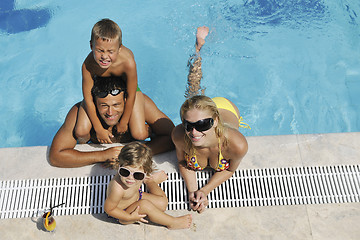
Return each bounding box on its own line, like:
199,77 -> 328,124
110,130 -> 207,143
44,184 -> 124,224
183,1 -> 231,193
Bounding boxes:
0,165 -> 360,219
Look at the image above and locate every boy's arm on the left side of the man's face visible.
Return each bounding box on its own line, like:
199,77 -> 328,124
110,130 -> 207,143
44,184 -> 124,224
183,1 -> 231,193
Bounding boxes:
82,63 -> 113,143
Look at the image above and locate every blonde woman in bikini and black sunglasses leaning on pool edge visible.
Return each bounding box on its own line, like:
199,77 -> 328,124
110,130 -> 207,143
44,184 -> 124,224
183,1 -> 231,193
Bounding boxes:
172,26 -> 249,213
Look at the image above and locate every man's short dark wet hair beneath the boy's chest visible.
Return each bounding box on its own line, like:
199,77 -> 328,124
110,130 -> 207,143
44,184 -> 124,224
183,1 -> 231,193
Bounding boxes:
91,75 -> 127,100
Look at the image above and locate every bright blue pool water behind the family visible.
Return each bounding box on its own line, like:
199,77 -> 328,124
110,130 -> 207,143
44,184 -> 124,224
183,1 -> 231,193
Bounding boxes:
0,0 -> 360,147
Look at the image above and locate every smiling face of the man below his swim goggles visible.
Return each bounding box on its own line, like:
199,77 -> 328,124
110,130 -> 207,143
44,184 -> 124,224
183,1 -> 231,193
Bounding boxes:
96,92 -> 125,126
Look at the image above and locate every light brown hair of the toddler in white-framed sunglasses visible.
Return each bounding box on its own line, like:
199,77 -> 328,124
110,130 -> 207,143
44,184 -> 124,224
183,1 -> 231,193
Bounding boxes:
118,142 -> 154,174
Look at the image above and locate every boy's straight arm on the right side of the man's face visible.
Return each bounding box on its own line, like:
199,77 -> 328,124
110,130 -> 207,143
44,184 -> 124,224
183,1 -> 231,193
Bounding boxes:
117,61 -> 138,132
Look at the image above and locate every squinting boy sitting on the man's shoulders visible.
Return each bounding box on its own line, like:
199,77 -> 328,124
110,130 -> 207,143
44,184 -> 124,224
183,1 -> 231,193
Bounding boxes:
75,19 -> 149,143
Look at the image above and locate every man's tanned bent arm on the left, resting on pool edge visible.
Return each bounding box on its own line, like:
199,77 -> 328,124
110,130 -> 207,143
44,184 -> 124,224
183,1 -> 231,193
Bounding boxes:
49,104 -> 122,168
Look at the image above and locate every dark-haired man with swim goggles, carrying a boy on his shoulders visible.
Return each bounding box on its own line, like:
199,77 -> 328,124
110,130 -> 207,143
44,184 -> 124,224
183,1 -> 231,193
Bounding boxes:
49,77 -> 174,167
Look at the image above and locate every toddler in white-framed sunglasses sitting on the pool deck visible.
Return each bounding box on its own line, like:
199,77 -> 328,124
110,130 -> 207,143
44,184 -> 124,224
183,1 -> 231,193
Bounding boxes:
104,142 -> 192,229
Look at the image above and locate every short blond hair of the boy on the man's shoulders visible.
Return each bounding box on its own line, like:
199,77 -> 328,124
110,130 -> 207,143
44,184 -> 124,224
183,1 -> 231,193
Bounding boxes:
90,18 -> 122,47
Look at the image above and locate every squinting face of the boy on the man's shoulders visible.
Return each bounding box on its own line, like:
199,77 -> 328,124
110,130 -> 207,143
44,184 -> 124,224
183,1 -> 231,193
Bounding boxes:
90,38 -> 121,69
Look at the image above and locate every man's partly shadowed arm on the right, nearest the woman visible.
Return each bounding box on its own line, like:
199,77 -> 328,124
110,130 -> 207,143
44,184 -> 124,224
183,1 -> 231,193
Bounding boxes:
144,94 -> 174,155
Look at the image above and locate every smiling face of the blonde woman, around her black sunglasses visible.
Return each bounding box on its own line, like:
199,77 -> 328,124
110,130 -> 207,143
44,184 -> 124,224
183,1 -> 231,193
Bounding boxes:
184,108 -> 218,147
